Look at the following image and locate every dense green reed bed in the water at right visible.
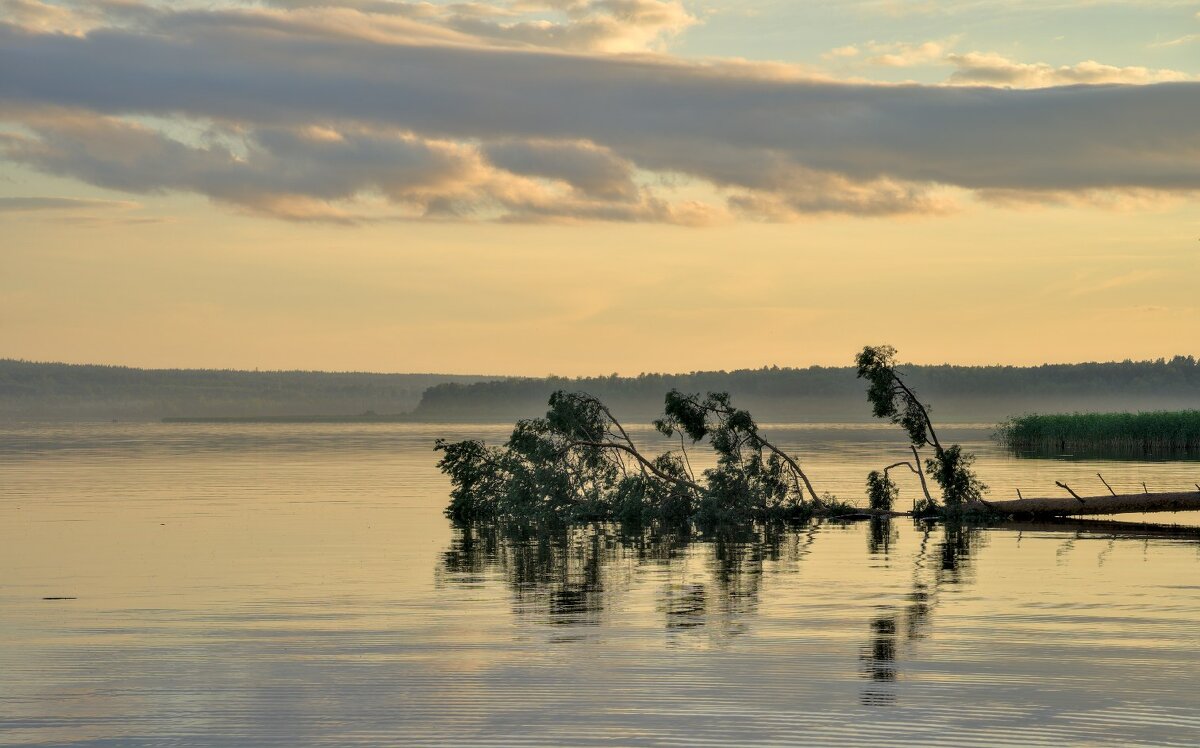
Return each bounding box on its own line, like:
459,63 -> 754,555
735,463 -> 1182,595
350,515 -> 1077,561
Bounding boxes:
997,411 -> 1200,456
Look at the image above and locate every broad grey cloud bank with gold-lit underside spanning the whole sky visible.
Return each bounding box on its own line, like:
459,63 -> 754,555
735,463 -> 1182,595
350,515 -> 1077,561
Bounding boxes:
0,7 -> 1200,223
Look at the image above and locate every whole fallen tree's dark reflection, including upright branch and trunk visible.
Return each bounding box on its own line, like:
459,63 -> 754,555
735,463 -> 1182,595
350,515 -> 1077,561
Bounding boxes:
437,519 -> 1200,706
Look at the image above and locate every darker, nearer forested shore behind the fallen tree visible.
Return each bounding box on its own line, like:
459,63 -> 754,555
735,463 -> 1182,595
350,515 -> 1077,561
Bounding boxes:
413,355 -> 1200,423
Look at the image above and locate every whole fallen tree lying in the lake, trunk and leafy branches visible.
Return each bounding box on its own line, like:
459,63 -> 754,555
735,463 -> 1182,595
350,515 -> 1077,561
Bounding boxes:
434,346 -> 1200,529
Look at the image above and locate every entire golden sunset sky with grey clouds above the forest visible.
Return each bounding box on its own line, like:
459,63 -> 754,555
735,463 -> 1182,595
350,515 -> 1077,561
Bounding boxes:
0,0 -> 1200,376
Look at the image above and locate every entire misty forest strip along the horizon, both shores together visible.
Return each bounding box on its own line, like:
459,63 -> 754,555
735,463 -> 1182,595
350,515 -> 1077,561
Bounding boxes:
0,357 -> 1200,423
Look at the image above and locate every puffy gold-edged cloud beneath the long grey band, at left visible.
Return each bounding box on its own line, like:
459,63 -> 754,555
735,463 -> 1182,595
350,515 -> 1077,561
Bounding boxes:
0,110 -> 719,223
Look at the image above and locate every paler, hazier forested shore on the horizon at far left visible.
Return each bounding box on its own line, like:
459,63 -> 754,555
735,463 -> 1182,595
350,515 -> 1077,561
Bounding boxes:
0,359 -> 493,420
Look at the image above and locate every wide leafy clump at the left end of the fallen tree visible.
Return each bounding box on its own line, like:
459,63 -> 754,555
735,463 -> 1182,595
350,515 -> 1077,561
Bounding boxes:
434,390 -> 823,527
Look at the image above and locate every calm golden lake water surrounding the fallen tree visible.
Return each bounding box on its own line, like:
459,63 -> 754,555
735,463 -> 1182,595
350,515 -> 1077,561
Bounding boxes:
0,424 -> 1200,746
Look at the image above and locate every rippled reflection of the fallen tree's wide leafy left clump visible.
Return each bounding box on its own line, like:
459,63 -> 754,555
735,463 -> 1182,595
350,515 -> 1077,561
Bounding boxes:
438,522 -> 814,634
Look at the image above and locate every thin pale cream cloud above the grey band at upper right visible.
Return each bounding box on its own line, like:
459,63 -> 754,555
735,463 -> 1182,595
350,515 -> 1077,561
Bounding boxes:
946,52 -> 1194,88
